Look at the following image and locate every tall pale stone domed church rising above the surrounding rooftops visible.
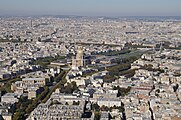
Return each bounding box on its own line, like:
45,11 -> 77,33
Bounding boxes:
72,46 -> 84,69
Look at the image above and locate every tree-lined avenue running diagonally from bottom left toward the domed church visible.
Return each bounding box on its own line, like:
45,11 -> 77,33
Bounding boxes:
13,71 -> 66,120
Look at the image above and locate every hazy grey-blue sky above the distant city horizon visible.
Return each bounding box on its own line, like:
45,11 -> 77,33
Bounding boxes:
0,0 -> 181,16
